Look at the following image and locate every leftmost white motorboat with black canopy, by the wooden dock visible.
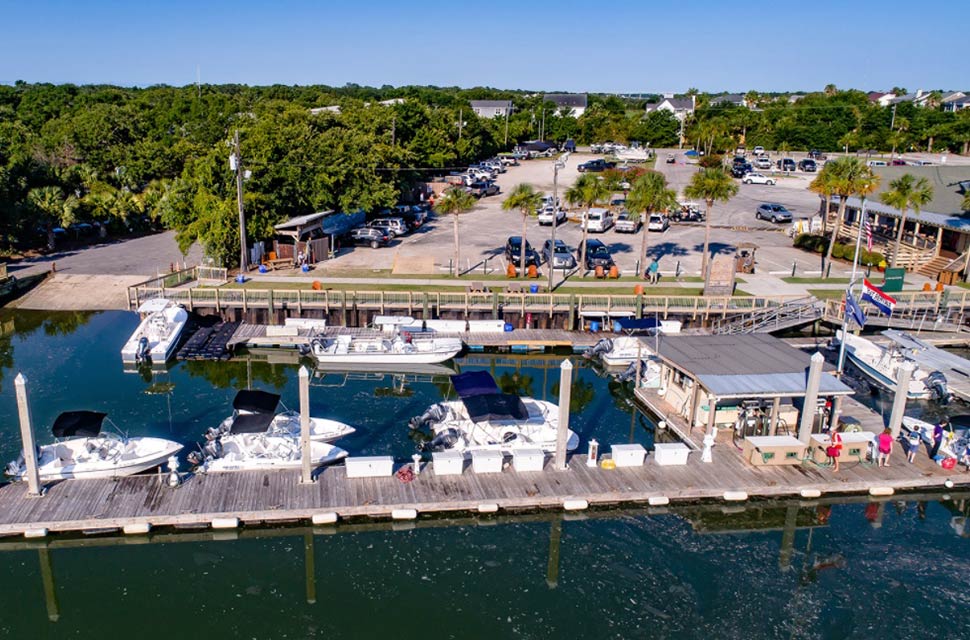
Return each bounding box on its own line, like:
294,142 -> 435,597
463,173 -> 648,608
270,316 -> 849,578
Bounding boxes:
6,411 -> 182,482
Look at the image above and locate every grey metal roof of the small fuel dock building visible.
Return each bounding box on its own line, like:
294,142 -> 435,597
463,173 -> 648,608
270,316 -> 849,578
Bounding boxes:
659,334 -> 852,398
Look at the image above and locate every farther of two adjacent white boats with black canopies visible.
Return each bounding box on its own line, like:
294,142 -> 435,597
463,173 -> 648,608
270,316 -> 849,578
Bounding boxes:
206,389 -> 355,442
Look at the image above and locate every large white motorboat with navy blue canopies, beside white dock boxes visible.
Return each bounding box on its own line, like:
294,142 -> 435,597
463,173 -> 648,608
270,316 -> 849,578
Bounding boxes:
410,371 -> 579,454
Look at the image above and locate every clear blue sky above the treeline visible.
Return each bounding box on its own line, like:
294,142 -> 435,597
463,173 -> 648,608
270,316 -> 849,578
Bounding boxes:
0,0 -> 970,92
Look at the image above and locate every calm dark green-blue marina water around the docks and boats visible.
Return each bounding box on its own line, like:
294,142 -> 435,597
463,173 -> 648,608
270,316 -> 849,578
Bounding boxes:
0,313 -> 970,639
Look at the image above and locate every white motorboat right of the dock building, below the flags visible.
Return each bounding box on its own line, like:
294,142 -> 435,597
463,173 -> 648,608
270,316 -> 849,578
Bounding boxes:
836,329 -> 950,402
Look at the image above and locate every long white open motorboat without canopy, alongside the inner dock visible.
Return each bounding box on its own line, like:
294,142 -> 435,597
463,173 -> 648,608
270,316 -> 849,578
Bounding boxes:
309,332 -> 464,364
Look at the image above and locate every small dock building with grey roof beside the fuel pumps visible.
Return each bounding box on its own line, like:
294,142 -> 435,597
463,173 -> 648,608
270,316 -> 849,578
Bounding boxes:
643,334 -> 853,442
